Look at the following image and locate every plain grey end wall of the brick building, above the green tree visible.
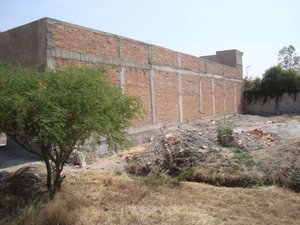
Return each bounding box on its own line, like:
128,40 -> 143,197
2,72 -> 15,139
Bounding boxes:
0,19 -> 46,66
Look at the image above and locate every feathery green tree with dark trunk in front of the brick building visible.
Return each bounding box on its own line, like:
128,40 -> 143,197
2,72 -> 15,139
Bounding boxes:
0,63 -> 141,198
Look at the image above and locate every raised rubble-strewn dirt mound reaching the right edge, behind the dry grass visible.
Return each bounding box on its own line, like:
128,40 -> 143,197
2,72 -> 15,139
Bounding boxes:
126,115 -> 300,183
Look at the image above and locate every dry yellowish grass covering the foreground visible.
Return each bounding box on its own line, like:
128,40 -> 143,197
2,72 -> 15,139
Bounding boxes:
2,171 -> 300,225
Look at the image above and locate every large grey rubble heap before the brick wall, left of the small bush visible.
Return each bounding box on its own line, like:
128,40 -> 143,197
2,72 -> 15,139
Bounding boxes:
127,128 -> 216,175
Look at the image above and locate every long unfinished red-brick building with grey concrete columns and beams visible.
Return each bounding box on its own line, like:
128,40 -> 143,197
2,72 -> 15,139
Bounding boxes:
0,18 -> 242,141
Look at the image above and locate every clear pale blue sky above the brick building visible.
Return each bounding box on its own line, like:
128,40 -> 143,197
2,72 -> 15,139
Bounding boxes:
0,0 -> 300,77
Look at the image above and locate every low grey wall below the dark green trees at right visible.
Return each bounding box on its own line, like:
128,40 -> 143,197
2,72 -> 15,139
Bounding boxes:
244,93 -> 300,116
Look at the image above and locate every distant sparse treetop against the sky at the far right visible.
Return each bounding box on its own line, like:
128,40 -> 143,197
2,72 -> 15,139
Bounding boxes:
278,45 -> 300,72
